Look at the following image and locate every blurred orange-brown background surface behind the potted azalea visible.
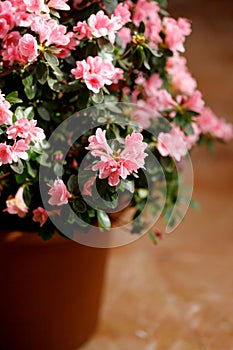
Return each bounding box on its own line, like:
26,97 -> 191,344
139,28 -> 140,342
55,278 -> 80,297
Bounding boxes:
82,0 -> 233,350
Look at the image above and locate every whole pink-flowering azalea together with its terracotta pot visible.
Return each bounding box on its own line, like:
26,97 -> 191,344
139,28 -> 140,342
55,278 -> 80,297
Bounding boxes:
0,0 -> 232,350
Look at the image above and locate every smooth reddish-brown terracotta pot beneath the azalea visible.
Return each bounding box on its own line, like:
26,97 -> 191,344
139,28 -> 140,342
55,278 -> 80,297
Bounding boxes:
0,231 -> 107,350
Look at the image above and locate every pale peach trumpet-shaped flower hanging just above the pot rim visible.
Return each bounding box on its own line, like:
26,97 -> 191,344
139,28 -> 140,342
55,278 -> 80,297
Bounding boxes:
4,187 -> 28,218
